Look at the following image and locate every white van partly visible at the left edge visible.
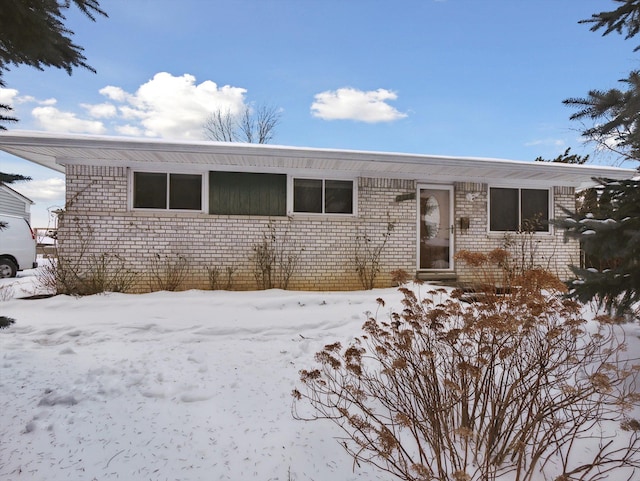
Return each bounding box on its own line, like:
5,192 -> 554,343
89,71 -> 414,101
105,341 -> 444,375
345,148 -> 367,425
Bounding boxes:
0,214 -> 38,278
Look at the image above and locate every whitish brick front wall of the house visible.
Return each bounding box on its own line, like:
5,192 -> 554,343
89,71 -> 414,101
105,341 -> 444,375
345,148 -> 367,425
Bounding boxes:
59,165 -> 578,291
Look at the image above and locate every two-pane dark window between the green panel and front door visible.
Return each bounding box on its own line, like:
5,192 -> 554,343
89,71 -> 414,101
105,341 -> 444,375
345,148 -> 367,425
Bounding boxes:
293,179 -> 353,214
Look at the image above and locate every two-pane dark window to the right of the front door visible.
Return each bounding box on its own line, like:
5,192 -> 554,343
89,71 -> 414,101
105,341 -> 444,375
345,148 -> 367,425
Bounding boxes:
489,187 -> 549,232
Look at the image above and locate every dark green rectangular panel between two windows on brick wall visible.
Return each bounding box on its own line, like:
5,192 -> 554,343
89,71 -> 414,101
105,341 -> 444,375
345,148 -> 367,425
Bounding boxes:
209,172 -> 287,216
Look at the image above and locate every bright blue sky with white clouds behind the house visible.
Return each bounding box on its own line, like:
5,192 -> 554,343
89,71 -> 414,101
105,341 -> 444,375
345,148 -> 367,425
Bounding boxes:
0,0 -> 638,225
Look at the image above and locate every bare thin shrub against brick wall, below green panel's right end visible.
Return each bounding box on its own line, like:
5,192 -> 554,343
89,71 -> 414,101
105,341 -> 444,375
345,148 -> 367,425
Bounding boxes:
252,219 -> 304,289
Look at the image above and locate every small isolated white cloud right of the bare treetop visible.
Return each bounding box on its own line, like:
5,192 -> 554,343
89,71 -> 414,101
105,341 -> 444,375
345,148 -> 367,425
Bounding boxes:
311,87 -> 407,123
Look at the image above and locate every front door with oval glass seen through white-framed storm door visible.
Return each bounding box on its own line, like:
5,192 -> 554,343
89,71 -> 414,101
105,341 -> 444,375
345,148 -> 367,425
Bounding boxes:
418,185 -> 453,270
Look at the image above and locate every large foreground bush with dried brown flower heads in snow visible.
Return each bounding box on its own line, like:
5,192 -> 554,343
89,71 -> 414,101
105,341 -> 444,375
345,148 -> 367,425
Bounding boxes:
293,263 -> 640,481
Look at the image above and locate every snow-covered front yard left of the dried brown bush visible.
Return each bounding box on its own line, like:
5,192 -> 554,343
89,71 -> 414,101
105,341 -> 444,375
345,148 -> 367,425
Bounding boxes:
0,264 -> 640,481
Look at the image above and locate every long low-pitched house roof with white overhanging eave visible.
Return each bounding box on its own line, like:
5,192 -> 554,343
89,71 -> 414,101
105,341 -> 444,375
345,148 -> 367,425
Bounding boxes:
0,131 -> 637,188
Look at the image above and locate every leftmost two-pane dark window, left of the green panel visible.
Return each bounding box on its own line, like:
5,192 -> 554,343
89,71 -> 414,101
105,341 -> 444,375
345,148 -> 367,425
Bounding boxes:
133,172 -> 202,210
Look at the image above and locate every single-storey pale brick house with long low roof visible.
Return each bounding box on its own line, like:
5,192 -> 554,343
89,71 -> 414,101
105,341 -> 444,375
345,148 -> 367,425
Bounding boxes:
0,132 -> 635,289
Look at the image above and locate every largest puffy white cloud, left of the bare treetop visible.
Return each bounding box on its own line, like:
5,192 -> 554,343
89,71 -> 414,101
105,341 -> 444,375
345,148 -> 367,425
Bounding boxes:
100,72 -> 247,139
